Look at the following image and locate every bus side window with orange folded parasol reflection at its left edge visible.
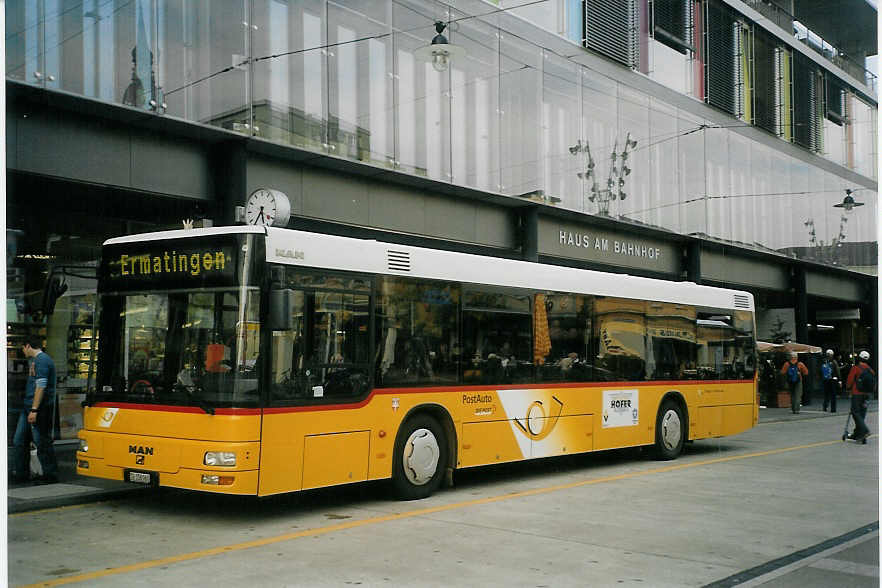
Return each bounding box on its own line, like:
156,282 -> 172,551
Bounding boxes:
534,294 -> 594,382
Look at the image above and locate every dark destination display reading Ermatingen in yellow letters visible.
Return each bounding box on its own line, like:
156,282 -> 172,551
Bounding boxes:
101,235 -> 239,292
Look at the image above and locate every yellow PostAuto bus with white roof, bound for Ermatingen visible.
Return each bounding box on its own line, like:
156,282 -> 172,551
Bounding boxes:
77,226 -> 758,499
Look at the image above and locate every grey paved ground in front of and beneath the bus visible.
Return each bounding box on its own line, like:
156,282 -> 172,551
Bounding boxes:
9,404 -> 879,588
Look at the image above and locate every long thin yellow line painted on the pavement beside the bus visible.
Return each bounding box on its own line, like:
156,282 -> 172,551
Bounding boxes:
22,439 -> 842,588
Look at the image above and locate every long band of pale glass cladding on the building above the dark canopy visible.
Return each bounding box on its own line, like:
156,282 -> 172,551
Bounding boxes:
5,0 -> 878,274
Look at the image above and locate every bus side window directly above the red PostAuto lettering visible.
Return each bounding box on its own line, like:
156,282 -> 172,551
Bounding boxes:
462,287 -> 533,384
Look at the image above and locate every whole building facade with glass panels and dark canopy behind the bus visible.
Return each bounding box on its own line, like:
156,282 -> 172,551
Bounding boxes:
6,0 -> 878,436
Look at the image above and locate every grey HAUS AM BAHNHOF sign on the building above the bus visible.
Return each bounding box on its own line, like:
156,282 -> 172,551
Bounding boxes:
538,219 -> 680,275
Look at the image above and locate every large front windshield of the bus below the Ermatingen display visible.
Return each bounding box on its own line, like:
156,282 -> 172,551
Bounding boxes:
96,287 -> 260,412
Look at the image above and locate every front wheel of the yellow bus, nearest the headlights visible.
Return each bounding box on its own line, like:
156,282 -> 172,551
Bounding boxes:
392,415 -> 447,500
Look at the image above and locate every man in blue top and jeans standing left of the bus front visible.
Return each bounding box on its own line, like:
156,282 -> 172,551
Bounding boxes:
13,336 -> 58,482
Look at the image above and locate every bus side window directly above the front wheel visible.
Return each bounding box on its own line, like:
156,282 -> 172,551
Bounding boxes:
376,278 -> 460,387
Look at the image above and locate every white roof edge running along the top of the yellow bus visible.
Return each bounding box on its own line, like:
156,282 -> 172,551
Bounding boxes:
104,225 -> 754,311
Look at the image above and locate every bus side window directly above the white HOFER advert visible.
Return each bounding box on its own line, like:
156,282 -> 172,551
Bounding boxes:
592,296 -> 647,381
